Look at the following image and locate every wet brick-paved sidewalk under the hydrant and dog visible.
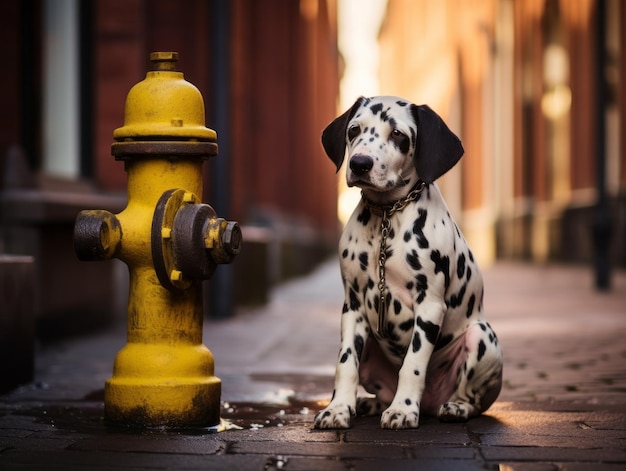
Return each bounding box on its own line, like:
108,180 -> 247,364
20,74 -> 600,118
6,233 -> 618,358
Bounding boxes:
0,260 -> 626,471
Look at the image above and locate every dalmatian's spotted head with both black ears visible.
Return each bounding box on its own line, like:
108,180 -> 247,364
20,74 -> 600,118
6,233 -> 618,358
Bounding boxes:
322,96 -> 463,199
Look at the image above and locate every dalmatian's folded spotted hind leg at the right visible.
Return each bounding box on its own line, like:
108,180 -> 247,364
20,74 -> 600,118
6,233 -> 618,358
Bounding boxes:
437,321 -> 502,422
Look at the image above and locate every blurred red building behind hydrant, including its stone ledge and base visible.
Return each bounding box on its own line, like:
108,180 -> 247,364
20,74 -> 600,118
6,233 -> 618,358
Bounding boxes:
0,0 -> 340,332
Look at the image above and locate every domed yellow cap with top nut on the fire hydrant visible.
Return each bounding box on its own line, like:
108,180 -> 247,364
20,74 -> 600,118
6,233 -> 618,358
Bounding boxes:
113,52 -> 217,141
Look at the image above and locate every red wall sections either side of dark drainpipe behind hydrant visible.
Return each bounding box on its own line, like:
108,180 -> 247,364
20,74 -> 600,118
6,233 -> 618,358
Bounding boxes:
95,0 -> 339,232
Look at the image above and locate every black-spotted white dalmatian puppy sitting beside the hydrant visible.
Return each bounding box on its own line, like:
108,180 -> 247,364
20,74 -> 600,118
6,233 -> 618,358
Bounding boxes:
314,96 -> 502,429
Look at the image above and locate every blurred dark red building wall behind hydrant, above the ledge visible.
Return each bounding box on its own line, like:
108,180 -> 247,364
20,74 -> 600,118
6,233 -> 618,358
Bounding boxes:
0,0 -> 338,236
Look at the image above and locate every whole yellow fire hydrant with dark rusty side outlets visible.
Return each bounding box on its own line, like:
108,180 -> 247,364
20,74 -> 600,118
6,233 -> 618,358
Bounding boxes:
74,52 -> 241,427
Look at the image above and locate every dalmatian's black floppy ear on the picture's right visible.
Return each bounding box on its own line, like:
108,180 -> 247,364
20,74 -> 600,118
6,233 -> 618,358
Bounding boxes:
411,105 -> 463,184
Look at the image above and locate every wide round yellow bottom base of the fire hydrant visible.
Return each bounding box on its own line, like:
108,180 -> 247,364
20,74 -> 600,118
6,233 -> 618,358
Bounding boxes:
104,376 -> 222,428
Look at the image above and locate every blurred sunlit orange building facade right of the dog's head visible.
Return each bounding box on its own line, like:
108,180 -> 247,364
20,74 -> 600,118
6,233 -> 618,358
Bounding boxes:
379,0 -> 626,267
